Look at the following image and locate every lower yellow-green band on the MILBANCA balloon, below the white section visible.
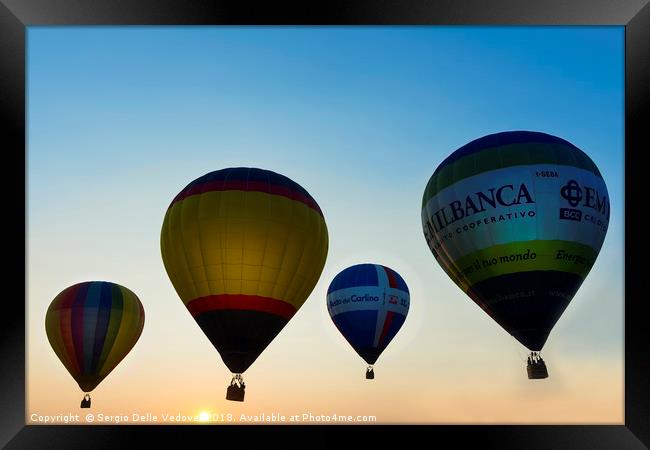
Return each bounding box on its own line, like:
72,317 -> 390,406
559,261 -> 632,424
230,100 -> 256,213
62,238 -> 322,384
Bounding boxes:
440,240 -> 598,290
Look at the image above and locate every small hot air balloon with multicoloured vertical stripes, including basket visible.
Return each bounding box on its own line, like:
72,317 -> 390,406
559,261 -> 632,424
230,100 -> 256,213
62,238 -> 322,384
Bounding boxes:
45,281 -> 144,407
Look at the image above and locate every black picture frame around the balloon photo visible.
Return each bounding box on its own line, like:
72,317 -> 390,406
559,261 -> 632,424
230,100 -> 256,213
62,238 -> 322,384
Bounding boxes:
0,0 -> 650,450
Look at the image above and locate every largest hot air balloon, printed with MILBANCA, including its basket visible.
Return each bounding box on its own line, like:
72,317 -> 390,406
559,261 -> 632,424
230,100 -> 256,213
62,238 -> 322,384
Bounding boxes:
422,131 -> 610,379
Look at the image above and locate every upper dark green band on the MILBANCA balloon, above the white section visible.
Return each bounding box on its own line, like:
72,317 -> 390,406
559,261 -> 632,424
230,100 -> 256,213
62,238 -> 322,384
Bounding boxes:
422,143 -> 602,207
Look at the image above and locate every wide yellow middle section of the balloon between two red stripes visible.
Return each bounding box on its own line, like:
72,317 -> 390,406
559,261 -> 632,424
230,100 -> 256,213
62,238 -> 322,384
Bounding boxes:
161,191 -> 328,308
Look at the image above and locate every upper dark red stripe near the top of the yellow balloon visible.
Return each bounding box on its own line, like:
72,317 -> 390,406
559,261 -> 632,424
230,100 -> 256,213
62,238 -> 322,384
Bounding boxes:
169,180 -> 323,217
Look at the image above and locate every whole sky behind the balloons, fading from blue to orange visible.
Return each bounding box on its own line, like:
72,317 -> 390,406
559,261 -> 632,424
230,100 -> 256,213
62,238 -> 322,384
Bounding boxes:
26,26 -> 624,424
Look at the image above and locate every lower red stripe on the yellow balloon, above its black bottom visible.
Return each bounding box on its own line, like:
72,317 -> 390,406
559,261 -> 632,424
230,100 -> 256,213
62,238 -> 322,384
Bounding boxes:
186,294 -> 296,320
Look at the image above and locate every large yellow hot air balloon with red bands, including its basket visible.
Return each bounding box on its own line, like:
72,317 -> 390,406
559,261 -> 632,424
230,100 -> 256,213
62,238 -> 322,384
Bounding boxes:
160,167 -> 328,401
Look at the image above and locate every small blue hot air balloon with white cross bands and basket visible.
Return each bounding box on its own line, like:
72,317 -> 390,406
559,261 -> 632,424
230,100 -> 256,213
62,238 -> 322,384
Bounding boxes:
327,264 -> 410,379
